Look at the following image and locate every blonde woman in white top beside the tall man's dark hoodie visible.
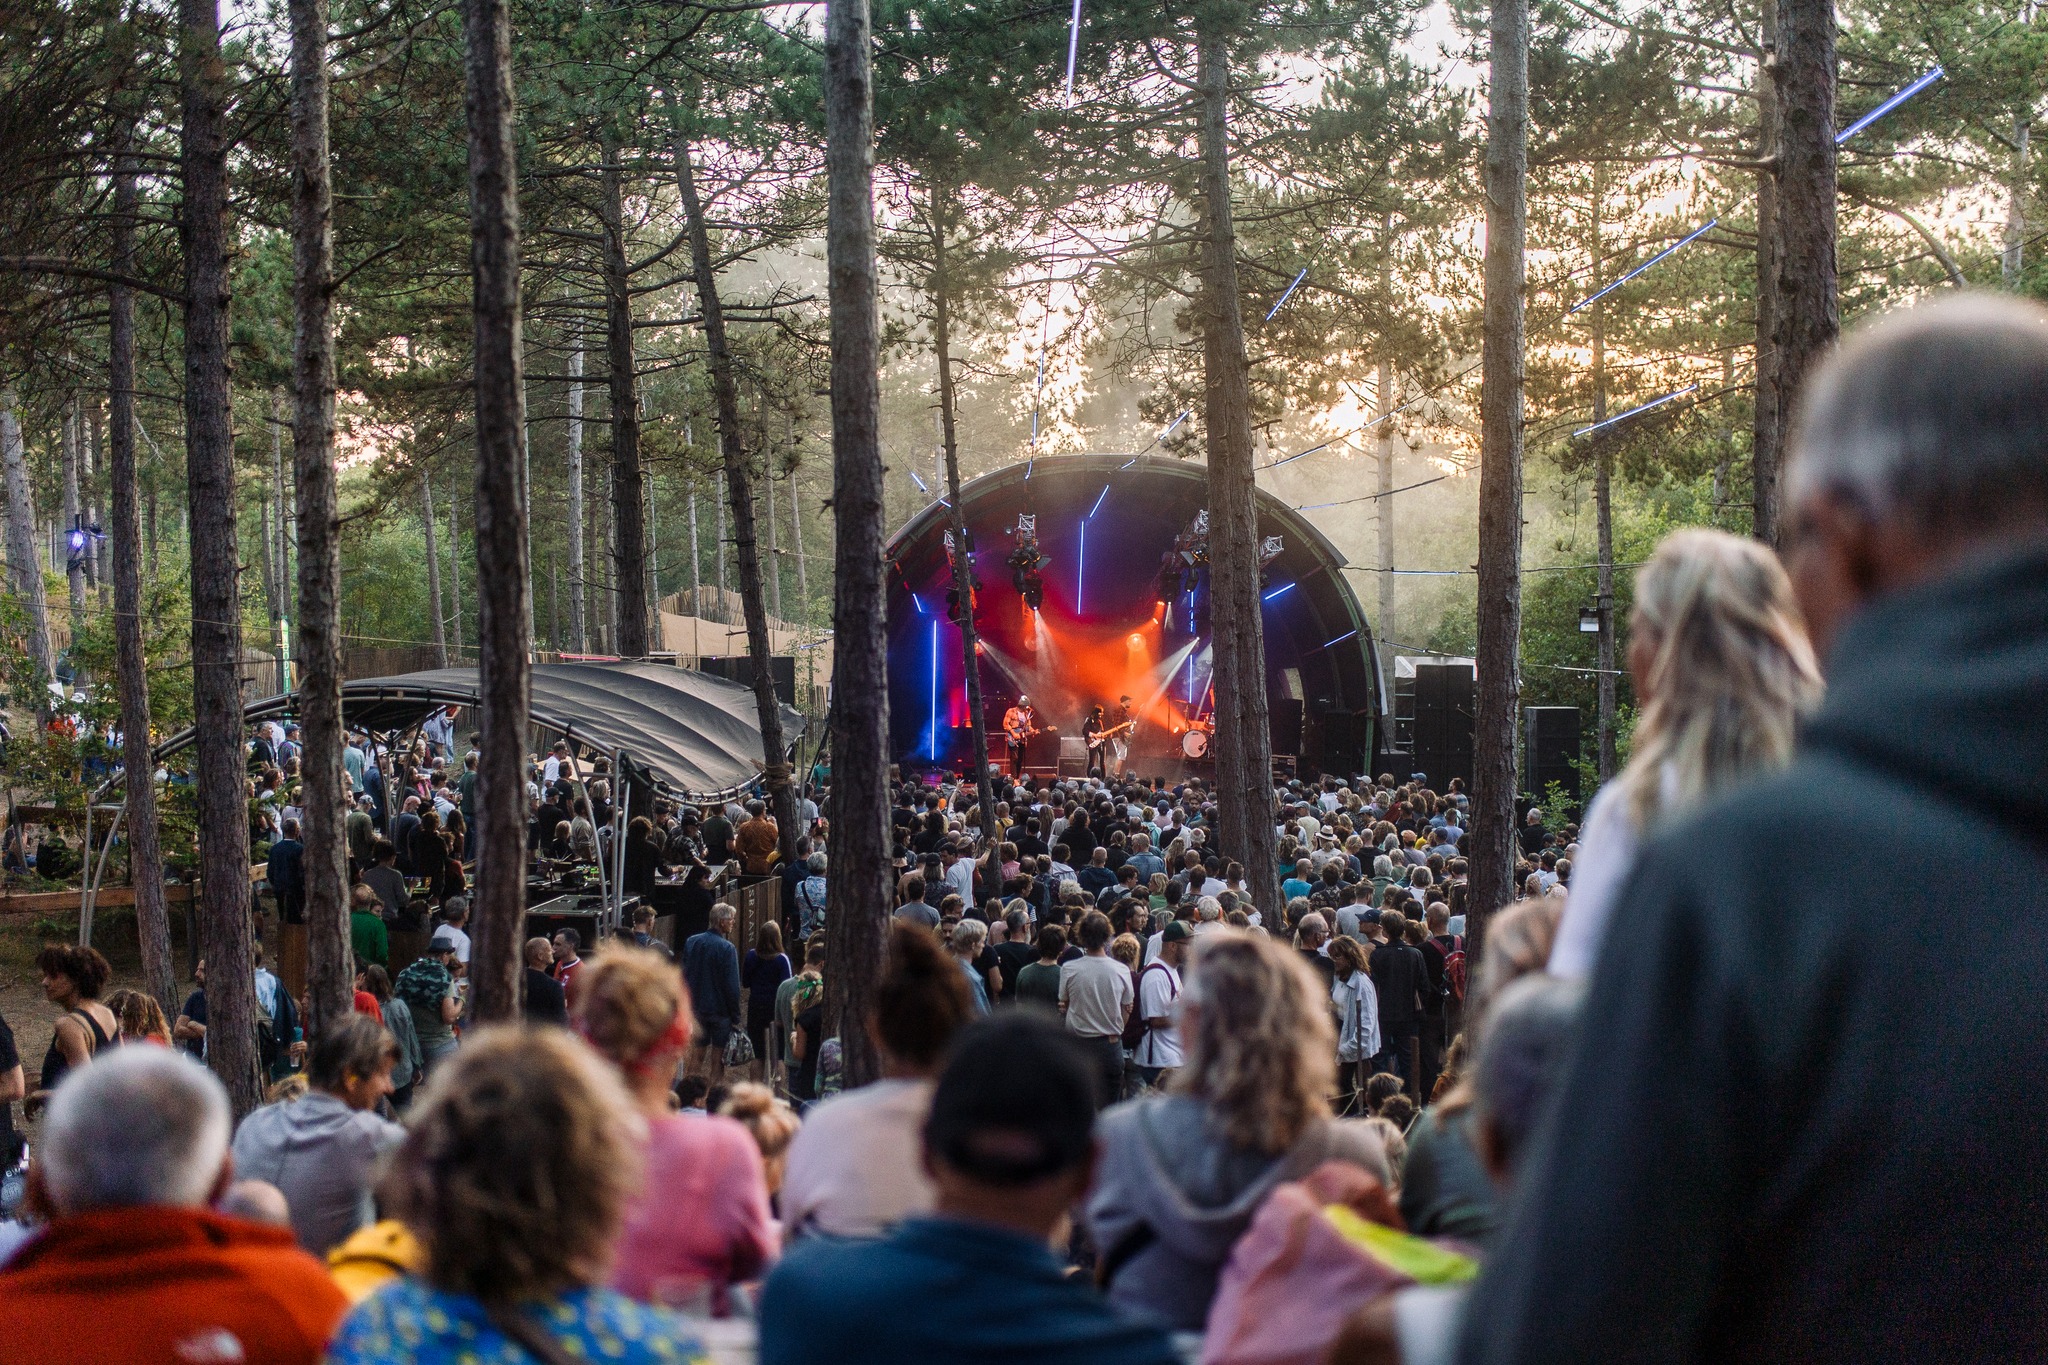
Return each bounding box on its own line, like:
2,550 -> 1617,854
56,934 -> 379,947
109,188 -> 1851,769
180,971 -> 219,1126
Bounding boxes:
1550,530 -> 1821,976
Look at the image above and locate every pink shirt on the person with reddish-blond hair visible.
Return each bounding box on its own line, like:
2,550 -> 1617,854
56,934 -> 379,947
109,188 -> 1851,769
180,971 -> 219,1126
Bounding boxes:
612,1113 -> 778,1306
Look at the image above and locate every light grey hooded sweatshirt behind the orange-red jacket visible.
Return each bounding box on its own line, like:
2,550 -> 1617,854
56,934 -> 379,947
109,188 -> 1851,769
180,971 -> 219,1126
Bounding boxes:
233,1091 -> 406,1257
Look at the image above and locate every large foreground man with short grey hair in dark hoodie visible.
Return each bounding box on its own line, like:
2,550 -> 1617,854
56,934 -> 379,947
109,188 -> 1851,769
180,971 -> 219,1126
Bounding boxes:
1458,297 -> 2048,1365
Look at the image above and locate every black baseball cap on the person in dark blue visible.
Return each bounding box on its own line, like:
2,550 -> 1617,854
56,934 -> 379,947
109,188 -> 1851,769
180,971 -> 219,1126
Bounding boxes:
924,1011 -> 1096,1187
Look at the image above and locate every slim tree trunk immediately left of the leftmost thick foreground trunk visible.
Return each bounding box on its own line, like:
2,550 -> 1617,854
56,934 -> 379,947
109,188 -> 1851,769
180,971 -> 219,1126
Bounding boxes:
106,149 -> 178,1011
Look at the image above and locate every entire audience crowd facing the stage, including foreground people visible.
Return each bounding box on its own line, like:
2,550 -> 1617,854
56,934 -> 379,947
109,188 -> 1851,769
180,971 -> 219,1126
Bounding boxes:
0,299 -> 2048,1365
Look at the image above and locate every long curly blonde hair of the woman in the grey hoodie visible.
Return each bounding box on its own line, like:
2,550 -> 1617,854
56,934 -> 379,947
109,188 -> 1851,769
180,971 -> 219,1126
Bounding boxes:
1174,933 -> 1337,1156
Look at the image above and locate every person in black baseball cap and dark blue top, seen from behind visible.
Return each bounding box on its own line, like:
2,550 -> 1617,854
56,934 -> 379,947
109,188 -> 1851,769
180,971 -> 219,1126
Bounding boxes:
760,1009 -> 1176,1365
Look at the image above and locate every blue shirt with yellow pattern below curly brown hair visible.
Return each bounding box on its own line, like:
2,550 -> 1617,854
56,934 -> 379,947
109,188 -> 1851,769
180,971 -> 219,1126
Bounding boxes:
328,1275 -> 709,1365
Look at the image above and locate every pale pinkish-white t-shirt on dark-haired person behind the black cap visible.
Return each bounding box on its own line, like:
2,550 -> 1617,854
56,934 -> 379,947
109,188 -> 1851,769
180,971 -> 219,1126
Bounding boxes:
782,1080 -> 937,1238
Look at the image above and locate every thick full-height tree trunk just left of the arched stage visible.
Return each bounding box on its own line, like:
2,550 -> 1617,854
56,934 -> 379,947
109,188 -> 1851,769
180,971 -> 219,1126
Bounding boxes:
825,0 -> 893,1087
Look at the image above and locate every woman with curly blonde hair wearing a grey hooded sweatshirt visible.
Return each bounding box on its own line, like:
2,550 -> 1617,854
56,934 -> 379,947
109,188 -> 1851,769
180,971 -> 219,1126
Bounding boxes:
1083,931 -> 1393,1332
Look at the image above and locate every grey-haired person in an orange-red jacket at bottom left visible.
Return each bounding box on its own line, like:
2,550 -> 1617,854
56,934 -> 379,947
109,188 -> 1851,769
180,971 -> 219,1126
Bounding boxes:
0,1048 -> 348,1365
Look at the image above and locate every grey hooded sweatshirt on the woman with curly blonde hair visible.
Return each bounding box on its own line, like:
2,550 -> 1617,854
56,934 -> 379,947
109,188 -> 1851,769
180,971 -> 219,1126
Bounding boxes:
1085,1095 -> 1393,1332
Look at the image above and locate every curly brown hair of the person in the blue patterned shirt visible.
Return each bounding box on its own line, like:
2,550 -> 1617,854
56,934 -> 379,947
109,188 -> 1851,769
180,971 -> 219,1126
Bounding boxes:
379,1025 -> 645,1306
